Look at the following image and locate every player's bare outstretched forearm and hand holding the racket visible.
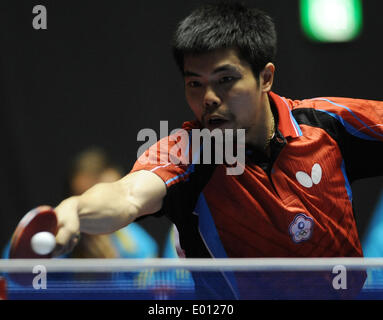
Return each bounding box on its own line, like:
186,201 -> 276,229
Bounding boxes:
53,170 -> 166,256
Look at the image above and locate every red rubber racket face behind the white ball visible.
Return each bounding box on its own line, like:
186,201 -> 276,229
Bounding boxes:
9,206 -> 58,259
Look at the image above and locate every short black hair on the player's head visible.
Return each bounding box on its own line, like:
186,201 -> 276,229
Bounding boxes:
172,1 -> 277,78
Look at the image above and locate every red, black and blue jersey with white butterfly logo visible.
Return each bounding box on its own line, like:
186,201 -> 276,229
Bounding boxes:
132,93 -> 383,257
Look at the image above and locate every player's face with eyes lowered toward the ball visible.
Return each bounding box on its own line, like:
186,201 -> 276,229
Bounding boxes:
184,49 -> 274,147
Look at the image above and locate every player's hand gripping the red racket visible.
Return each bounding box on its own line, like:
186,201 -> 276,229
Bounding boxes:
52,197 -> 80,257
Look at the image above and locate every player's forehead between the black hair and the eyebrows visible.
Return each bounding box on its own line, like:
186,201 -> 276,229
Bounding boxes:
184,48 -> 250,77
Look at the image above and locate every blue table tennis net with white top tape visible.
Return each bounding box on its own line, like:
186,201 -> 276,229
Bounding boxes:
0,258 -> 383,300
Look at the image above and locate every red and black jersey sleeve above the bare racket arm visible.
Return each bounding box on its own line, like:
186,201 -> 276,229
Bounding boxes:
131,122 -> 215,225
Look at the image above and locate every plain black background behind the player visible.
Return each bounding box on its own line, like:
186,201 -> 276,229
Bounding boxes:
0,0 -> 383,255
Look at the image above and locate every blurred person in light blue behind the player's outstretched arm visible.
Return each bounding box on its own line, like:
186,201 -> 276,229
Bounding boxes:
64,148 -> 158,258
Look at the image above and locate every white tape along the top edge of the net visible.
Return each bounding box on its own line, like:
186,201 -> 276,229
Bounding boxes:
0,258 -> 383,272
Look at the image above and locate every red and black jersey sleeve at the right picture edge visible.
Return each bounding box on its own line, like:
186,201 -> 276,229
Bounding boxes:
304,98 -> 383,182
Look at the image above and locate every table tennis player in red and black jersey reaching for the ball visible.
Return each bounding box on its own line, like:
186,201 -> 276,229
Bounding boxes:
49,4 -> 383,298
